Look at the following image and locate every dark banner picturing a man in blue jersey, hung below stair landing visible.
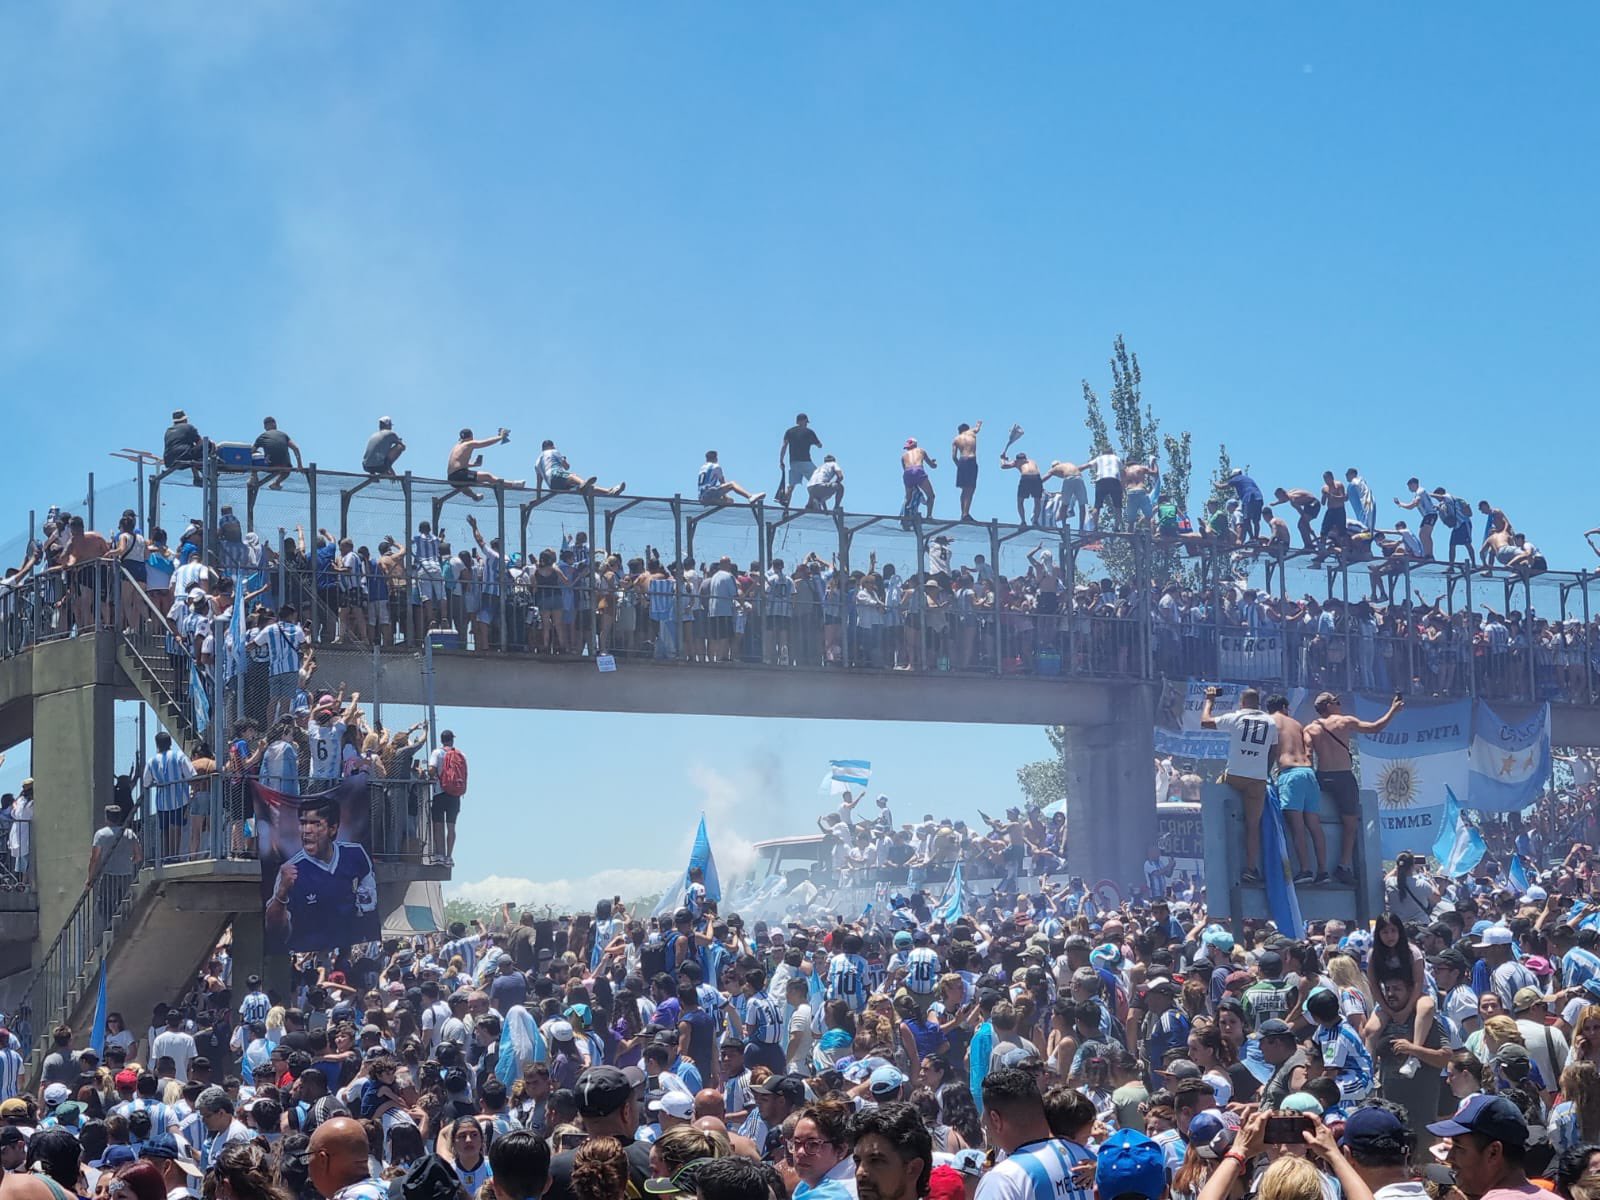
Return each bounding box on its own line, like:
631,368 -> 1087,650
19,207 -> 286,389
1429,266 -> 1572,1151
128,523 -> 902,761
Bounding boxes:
250,774 -> 382,954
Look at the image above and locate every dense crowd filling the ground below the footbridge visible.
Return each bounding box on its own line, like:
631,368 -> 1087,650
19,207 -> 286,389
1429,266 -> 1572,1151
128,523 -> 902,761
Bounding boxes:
15,819 -> 1600,1200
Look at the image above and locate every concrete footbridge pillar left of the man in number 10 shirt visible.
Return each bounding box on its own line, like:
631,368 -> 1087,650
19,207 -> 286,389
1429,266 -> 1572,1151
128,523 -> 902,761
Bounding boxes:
1062,685 -> 1157,888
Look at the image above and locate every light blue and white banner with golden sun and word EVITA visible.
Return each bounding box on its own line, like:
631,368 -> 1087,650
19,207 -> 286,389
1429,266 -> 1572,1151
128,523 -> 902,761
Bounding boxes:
1355,696 -> 1472,859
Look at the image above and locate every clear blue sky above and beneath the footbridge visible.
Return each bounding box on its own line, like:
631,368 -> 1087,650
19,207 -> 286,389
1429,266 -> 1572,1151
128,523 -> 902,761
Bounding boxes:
0,3 -> 1600,908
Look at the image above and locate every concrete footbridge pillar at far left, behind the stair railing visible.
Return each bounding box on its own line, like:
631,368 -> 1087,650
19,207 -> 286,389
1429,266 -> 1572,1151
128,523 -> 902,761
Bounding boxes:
34,684 -> 117,954
